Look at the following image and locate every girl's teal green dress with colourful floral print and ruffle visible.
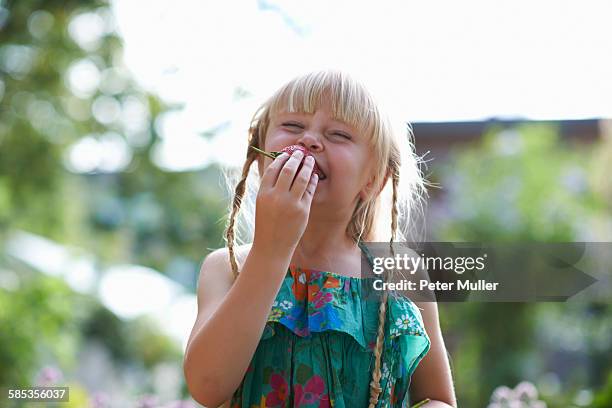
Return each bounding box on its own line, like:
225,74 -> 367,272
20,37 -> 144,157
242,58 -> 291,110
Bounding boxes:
230,243 -> 430,408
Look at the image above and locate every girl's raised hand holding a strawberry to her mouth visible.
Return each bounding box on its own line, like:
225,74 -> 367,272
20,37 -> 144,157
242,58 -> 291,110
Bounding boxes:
253,151 -> 318,253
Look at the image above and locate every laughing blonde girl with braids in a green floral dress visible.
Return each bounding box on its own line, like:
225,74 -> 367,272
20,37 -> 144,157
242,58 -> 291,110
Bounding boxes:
184,71 -> 456,408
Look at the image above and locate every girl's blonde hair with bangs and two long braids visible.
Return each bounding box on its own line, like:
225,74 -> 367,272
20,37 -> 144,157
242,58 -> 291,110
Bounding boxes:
225,70 -> 427,408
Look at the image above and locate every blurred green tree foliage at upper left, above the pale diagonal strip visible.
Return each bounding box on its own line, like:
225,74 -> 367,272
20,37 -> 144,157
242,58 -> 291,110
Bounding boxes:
0,0 -> 226,289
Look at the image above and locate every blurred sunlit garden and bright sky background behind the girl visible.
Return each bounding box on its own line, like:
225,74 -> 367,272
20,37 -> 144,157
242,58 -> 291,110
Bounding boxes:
0,0 -> 612,407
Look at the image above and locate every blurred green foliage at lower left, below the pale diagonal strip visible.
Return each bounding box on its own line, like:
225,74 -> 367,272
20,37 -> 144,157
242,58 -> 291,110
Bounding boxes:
0,265 -> 182,400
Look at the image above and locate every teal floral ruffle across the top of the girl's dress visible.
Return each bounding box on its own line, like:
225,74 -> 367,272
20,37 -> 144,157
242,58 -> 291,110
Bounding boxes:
262,265 -> 430,377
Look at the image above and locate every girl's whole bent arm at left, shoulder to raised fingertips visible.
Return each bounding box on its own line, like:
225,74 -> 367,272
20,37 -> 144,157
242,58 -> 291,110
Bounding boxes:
183,151 -> 318,407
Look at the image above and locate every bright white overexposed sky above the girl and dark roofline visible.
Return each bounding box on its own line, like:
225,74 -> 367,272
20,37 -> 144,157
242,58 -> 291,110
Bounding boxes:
106,0 -> 612,170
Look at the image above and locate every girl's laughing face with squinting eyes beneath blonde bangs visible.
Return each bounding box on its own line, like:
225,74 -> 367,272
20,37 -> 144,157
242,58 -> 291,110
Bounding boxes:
260,99 -> 373,210
